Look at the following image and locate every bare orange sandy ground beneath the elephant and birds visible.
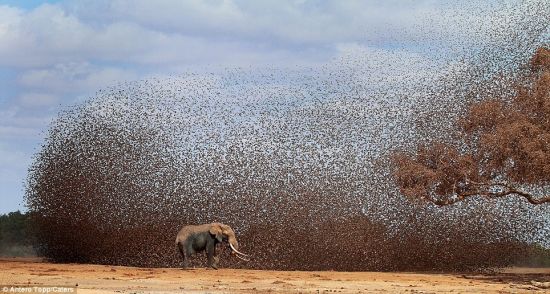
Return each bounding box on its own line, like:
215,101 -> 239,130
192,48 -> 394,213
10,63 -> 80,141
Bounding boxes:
0,258 -> 550,293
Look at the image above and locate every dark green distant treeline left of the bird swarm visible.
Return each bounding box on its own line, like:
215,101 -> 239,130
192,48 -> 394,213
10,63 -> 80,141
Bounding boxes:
0,211 -> 35,256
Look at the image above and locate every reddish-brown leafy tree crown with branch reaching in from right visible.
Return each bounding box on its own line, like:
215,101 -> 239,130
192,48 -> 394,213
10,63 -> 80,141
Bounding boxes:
392,48 -> 550,205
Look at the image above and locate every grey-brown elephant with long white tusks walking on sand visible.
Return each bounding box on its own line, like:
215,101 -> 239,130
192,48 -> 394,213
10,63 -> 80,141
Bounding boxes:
176,223 -> 249,269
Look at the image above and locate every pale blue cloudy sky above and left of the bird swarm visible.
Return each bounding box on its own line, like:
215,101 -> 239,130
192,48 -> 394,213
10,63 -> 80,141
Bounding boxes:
0,0 -> 528,213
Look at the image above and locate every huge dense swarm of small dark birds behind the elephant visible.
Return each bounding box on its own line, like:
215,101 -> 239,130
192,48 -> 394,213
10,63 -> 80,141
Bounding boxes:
26,1 -> 550,270
